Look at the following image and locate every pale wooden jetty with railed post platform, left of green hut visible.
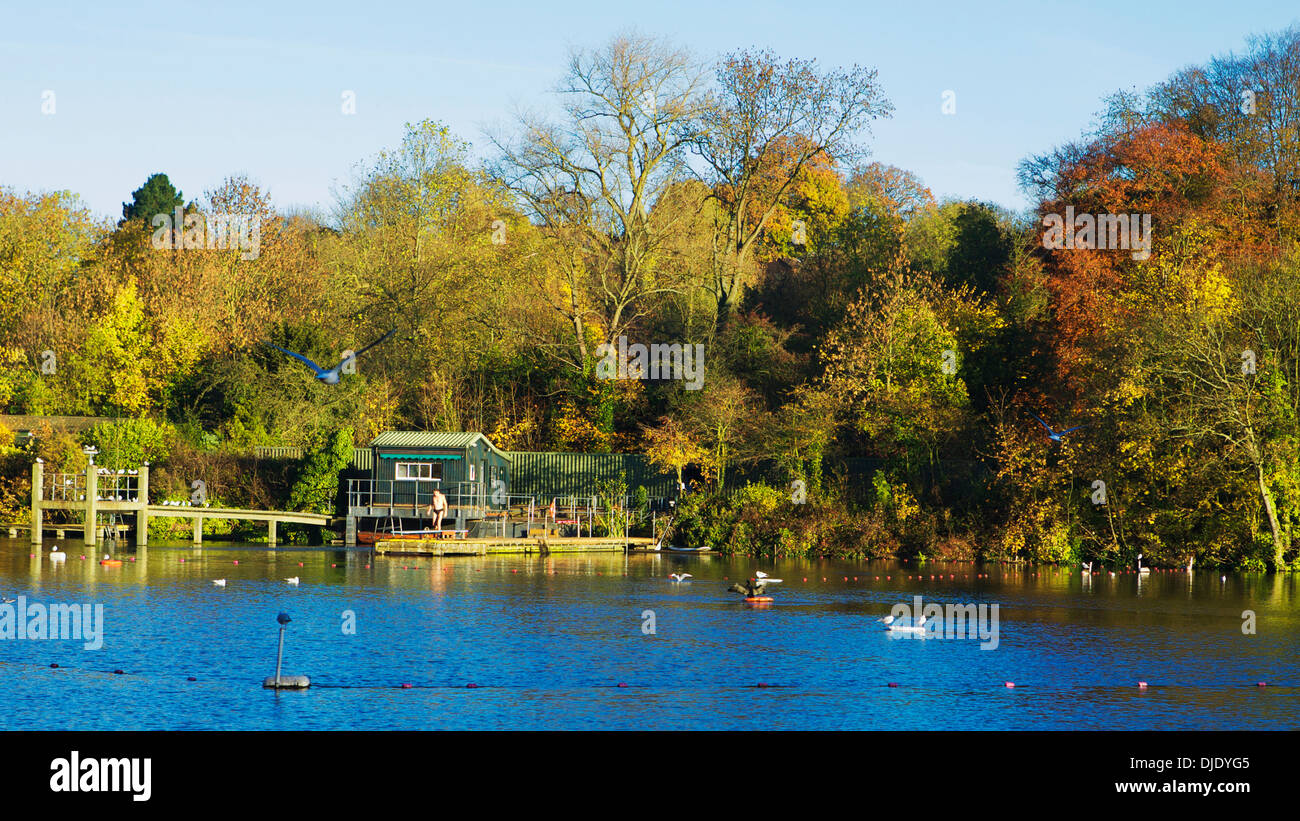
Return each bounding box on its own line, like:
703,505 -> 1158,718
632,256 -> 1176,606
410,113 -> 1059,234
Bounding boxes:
26,459 -> 330,547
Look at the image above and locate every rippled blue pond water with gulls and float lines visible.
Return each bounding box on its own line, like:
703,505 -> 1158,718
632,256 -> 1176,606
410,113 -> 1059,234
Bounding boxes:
0,539 -> 1300,730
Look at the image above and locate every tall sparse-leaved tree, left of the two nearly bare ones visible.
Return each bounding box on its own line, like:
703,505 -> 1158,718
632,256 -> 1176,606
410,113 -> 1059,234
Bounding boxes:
493,35 -> 699,370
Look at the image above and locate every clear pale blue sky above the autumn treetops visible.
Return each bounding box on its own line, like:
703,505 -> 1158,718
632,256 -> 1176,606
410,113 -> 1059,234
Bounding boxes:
0,0 -> 1300,217
